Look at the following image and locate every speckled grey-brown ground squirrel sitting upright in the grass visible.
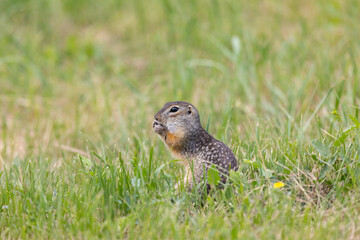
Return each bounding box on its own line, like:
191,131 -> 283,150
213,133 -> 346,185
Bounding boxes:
153,101 -> 238,190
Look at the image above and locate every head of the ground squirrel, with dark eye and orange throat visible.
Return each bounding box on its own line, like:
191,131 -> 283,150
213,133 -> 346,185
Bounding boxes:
153,101 -> 202,146
